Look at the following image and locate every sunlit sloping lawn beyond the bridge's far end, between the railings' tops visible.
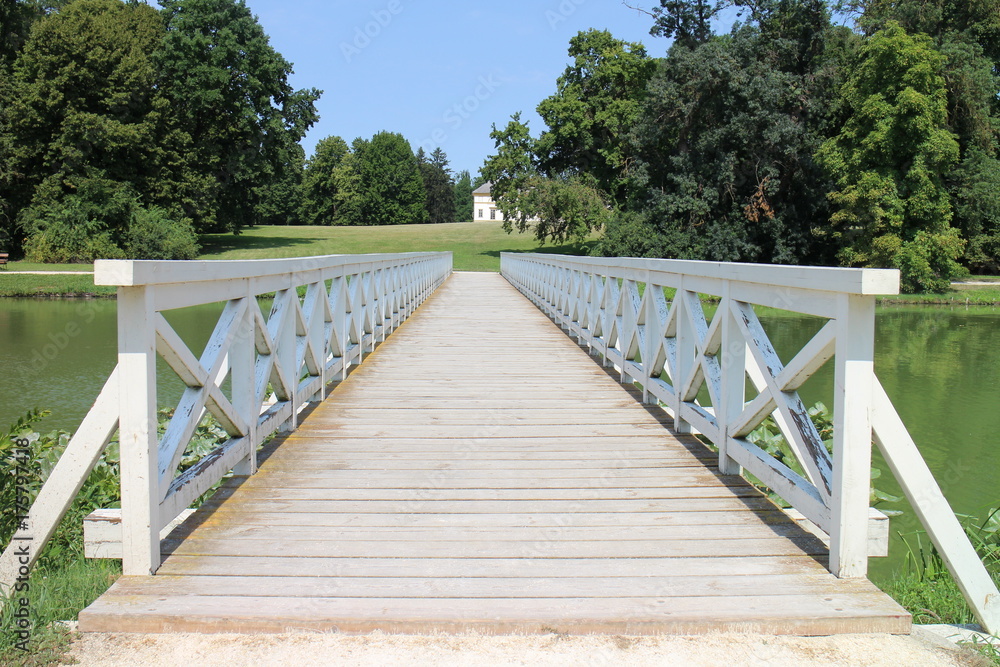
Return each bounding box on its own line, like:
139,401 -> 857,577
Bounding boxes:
200,222 -> 596,271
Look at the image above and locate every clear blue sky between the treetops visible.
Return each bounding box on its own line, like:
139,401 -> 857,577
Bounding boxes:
240,0 -> 668,174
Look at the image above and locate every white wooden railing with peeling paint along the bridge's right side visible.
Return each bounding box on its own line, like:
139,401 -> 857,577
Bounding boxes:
501,253 -> 1000,633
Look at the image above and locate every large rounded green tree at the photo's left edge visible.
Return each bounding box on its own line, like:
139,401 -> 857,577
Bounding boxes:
0,0 -> 167,258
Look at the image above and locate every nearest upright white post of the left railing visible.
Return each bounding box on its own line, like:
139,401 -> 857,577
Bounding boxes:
118,287 -> 160,576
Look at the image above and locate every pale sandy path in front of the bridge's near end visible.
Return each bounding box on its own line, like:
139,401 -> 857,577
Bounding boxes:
70,633 -> 984,667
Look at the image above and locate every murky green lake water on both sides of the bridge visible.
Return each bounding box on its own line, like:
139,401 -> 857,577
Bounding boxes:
0,299 -> 1000,579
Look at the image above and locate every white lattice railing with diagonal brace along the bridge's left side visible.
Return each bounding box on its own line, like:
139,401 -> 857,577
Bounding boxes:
0,253 -> 452,592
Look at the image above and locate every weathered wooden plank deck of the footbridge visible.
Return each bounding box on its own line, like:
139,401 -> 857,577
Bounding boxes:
80,273 -> 910,634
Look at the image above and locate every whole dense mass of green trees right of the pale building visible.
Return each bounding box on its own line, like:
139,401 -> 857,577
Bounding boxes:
482,0 -> 1000,291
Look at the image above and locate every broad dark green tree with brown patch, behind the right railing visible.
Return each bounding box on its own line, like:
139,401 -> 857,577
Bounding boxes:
600,5 -> 840,263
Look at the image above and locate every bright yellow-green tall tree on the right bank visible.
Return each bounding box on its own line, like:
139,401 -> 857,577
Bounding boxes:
817,22 -> 964,291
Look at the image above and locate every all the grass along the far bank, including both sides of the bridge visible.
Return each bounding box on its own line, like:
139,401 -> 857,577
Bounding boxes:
0,222 -> 1000,307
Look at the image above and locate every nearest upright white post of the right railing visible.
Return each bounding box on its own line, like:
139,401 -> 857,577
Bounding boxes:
830,294 -> 875,578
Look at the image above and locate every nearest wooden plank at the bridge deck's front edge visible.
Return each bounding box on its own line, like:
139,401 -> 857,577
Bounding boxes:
79,592 -> 910,634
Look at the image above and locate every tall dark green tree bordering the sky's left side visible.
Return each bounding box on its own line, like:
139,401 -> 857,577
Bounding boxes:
157,0 -> 320,231
